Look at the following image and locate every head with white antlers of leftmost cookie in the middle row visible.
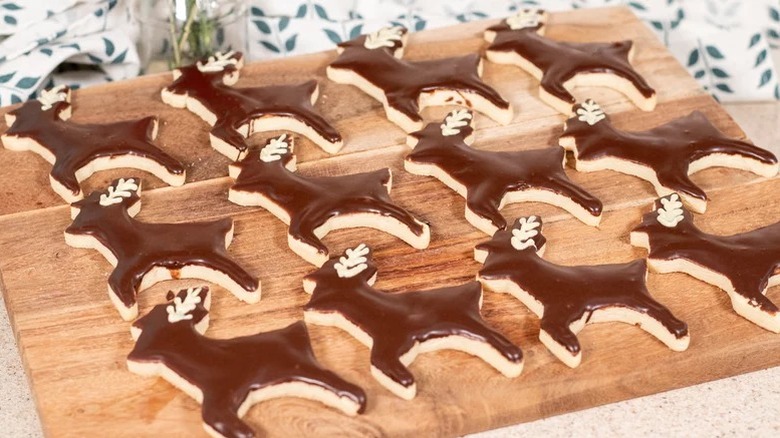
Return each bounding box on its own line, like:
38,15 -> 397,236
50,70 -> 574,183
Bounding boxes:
69,178 -> 141,221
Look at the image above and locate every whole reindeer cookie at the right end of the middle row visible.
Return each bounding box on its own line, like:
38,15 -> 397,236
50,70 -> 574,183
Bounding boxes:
559,99 -> 778,213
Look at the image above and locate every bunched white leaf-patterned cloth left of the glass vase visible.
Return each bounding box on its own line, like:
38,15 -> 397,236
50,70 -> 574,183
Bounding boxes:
0,0 -> 139,105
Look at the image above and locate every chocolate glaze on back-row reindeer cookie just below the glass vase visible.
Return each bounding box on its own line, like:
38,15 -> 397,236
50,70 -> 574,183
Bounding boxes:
166,53 -> 342,157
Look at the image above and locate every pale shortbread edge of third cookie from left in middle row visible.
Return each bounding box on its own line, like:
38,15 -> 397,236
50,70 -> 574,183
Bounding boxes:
404,157 -> 601,236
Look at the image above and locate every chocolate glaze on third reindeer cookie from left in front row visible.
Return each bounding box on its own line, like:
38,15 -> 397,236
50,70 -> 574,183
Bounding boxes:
476,216 -> 688,354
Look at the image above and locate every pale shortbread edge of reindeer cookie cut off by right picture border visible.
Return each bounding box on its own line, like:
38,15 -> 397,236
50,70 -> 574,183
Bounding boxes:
631,231 -> 780,333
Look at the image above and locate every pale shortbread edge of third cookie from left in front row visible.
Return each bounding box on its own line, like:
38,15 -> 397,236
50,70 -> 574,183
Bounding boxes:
477,276 -> 690,368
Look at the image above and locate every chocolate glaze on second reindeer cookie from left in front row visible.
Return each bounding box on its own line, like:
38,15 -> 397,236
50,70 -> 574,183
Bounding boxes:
304,246 -> 523,394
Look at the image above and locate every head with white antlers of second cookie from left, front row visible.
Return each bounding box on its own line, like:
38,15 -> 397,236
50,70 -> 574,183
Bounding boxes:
303,243 -> 377,293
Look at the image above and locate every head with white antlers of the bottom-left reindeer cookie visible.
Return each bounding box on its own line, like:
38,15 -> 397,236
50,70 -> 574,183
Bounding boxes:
131,286 -> 211,339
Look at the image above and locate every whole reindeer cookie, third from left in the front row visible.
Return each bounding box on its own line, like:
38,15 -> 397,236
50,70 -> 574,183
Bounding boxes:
474,216 -> 690,368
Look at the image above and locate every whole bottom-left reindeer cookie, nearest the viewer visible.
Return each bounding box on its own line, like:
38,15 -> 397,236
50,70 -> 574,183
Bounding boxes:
127,287 -> 366,438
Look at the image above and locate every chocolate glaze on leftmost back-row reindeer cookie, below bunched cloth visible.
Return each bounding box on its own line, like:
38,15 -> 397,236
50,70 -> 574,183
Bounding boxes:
4,88 -> 184,198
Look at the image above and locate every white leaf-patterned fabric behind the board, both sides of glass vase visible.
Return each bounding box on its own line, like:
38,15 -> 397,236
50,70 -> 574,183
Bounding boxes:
0,0 -> 780,105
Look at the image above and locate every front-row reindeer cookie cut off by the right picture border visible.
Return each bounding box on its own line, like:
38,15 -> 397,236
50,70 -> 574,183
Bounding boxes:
631,193 -> 780,333
